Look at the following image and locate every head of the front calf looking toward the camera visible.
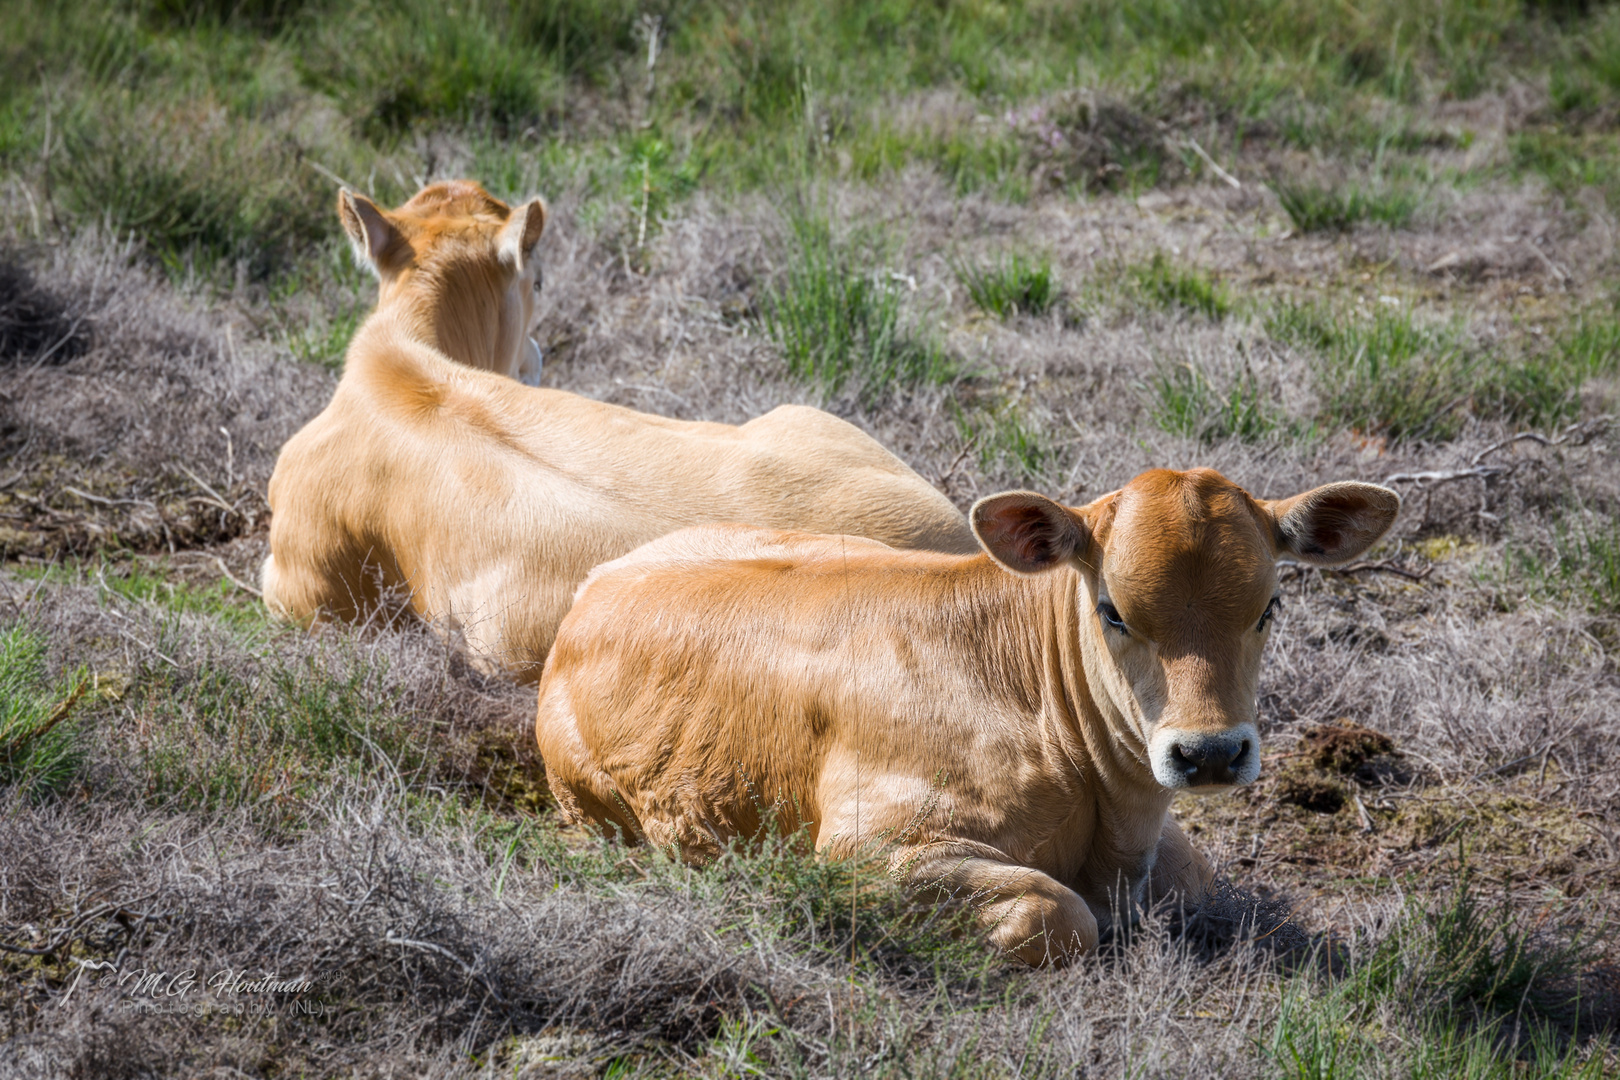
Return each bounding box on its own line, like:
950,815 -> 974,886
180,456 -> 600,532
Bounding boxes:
972,470 -> 1400,790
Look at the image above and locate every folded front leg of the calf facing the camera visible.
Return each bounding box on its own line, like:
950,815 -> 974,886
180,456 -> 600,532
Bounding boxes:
889,840 -> 1097,967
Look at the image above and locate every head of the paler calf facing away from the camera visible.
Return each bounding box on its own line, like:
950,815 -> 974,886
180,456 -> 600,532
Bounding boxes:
337,180 -> 546,385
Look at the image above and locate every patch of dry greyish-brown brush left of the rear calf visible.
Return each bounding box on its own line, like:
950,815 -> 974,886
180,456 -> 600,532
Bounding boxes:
0,233 -> 332,559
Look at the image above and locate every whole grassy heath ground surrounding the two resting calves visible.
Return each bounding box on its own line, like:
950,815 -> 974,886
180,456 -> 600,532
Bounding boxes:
0,0 -> 1620,1080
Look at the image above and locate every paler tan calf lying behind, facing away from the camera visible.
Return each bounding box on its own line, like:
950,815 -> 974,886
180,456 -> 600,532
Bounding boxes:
262,181 -> 974,678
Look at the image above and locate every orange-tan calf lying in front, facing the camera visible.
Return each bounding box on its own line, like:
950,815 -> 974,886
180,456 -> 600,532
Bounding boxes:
536,470 -> 1400,963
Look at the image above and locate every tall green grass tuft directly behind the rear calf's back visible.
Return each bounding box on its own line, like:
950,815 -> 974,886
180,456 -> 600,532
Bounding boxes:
760,214 -> 957,402
